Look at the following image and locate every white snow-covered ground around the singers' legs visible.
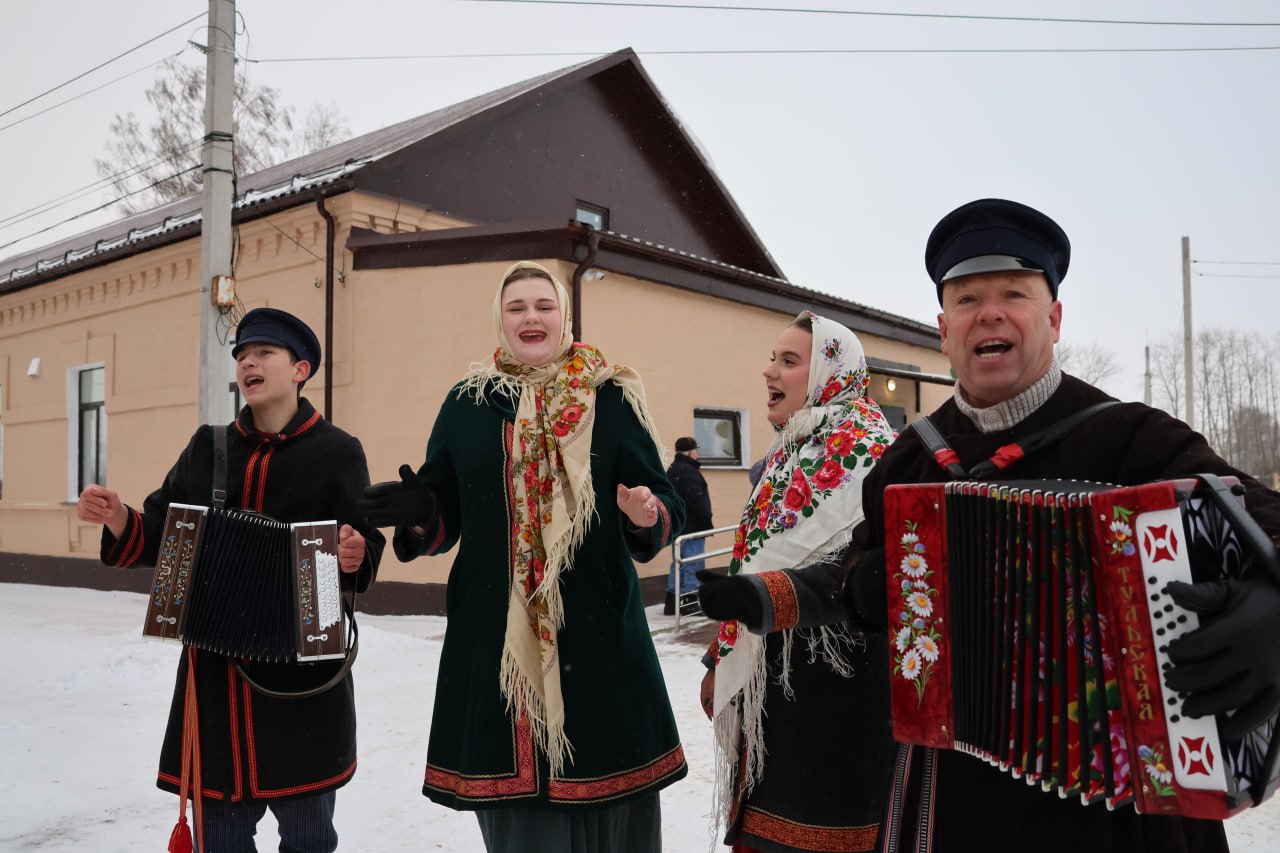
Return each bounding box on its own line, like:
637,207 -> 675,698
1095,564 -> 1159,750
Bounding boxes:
0,584 -> 1280,853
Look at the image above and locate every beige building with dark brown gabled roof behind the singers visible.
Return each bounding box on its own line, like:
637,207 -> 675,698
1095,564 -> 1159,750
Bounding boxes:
0,51 -> 951,612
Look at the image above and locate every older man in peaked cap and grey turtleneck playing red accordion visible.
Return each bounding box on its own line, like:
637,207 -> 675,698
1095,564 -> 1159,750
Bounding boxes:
849,199 -> 1280,853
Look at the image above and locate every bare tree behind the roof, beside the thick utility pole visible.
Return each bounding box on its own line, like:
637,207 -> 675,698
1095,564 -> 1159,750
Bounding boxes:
93,59 -> 348,214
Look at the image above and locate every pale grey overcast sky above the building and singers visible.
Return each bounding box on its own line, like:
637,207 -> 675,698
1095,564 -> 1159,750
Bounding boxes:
0,0 -> 1280,400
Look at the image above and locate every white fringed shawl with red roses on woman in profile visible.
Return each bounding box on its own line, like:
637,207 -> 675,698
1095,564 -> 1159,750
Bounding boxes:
712,311 -> 895,794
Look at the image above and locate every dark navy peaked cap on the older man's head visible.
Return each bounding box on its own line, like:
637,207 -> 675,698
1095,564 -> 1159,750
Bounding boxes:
924,199 -> 1071,304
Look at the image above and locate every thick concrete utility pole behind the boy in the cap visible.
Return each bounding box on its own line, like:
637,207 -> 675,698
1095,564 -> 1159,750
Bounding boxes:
200,0 -> 236,424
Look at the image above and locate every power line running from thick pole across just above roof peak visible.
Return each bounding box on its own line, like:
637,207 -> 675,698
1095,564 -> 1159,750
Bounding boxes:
248,43 -> 1280,64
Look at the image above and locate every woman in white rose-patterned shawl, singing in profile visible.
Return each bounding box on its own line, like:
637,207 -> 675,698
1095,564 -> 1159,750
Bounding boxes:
699,311 -> 893,853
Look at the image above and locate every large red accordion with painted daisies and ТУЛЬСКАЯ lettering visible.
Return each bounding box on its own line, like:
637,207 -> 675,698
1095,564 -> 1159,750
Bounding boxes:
884,476 -> 1277,818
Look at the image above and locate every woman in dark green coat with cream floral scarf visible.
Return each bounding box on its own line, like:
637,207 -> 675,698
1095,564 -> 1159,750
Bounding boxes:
364,261 -> 687,853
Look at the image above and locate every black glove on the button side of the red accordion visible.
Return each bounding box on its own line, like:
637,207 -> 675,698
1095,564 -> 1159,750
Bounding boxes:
1165,579 -> 1280,740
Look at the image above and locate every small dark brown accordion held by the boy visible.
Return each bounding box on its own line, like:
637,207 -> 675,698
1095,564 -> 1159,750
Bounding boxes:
142,503 -> 347,662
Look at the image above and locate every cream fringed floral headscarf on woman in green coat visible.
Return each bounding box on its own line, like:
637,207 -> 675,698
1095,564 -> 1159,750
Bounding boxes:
462,261 -> 662,776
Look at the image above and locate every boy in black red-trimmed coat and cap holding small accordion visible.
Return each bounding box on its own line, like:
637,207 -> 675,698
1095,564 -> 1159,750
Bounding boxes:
76,307 -> 385,853
